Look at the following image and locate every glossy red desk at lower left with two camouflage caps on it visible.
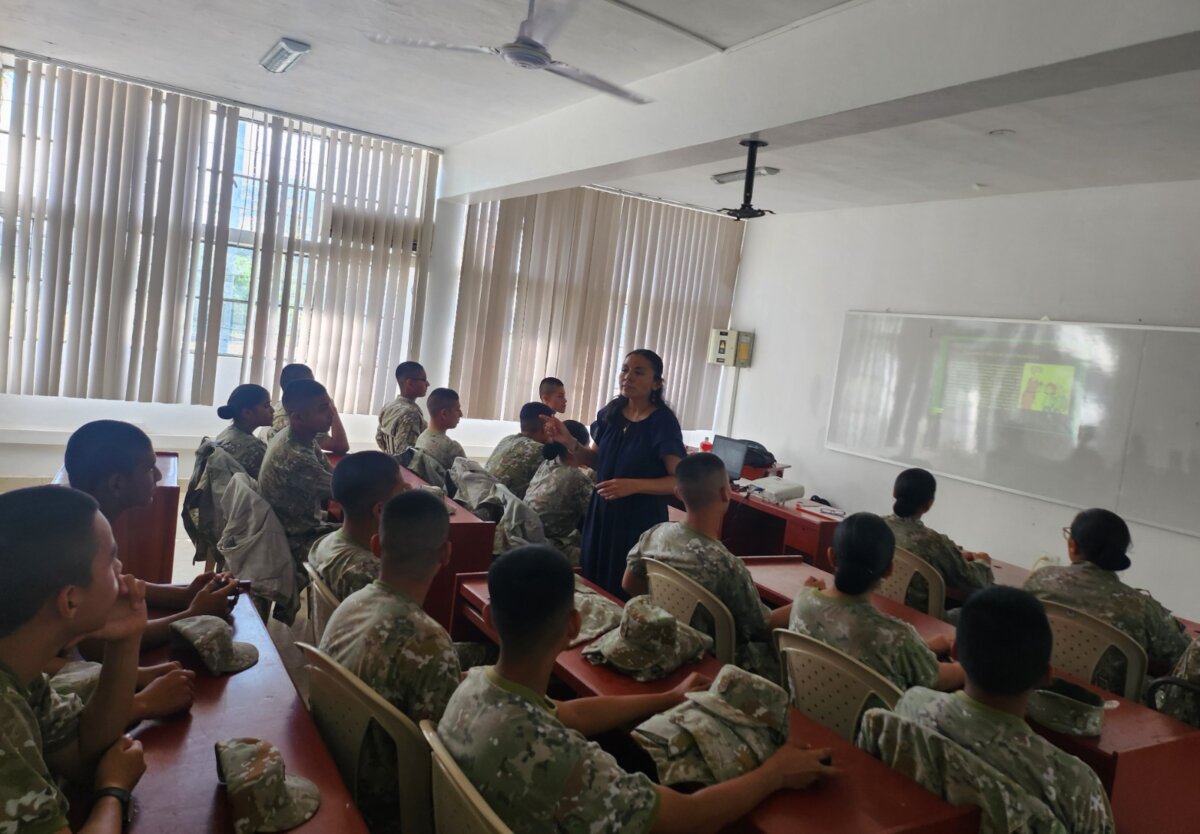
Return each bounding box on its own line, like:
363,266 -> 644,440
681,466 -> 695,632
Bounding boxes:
81,595 -> 367,834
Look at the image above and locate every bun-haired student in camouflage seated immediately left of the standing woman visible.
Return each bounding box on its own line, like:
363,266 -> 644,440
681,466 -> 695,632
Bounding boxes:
524,420 -> 595,565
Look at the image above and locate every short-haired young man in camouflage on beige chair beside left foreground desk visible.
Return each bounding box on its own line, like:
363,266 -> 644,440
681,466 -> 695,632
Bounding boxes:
320,489 -> 461,833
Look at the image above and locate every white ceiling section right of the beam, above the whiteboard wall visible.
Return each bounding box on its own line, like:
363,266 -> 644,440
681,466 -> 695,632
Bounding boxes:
600,71 -> 1200,214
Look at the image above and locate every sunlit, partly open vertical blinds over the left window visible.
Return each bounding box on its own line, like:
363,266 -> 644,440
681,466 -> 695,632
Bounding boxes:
0,53 -> 439,413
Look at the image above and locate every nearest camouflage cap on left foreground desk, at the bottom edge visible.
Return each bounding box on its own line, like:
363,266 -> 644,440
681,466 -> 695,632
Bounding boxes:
215,738 -> 320,834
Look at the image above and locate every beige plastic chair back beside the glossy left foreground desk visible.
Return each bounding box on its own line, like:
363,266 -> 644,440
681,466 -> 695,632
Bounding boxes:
296,643 -> 433,834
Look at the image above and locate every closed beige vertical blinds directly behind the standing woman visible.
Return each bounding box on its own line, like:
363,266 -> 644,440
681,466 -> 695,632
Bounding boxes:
450,188 -> 743,428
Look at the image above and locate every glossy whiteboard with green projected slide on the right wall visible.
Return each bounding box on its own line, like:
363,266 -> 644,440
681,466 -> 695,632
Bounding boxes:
826,312 -> 1200,535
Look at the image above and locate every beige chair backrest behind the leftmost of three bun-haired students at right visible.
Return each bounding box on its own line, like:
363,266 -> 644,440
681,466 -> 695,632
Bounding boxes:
774,629 -> 904,742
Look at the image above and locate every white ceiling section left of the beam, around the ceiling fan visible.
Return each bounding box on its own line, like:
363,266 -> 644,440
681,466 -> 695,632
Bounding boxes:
0,0 -> 845,148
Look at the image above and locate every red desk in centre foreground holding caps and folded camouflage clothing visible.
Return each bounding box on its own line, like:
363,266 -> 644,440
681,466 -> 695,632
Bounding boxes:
456,576 -> 979,834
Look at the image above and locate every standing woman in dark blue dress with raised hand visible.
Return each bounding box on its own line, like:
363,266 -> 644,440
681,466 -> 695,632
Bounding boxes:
542,349 -> 686,598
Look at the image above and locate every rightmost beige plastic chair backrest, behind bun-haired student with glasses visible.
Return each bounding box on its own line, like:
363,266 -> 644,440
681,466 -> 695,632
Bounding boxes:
1042,600 -> 1147,701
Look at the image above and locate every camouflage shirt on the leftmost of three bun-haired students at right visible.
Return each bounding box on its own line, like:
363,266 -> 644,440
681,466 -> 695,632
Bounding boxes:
787,588 -> 938,690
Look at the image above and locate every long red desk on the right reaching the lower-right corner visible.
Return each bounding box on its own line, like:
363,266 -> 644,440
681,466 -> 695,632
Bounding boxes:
745,557 -> 1200,834
